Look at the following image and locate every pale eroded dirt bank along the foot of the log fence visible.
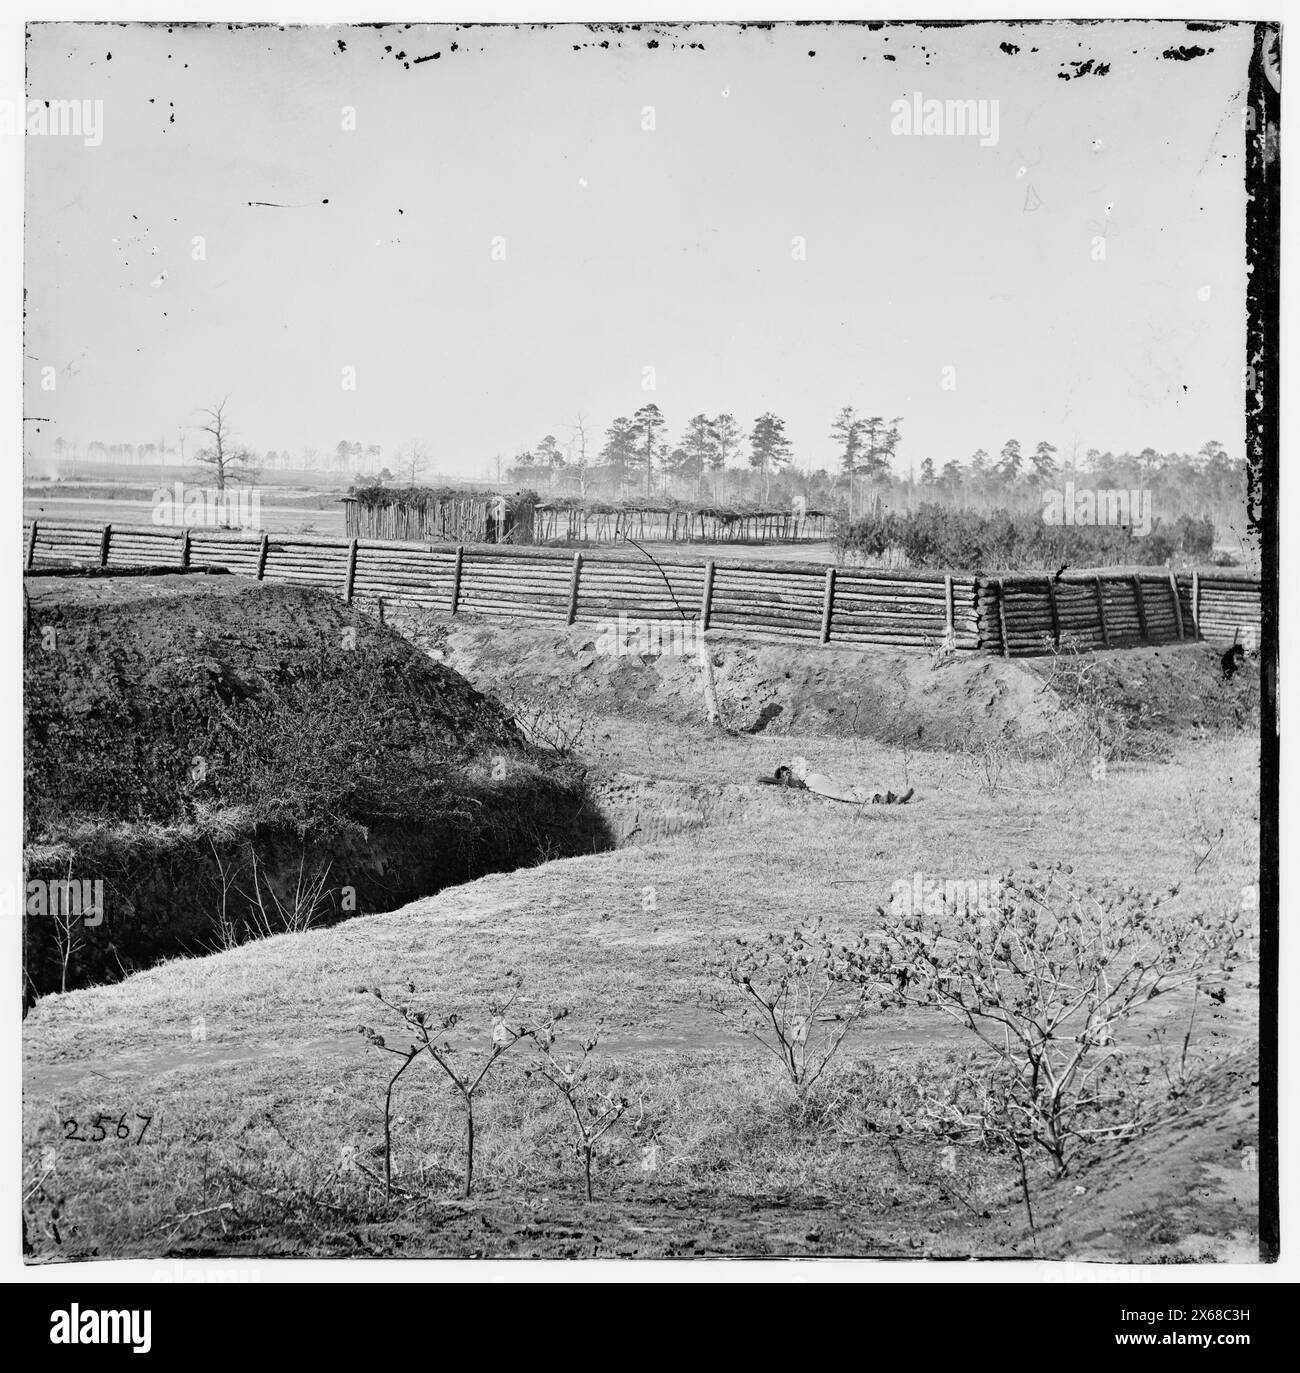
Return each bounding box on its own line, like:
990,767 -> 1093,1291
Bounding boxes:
390,611 -> 1259,750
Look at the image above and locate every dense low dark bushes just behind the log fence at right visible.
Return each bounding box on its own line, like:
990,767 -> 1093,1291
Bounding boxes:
835,505 -> 1215,571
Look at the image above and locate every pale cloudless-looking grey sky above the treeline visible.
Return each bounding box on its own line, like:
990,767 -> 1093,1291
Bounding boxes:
25,22 -> 1251,476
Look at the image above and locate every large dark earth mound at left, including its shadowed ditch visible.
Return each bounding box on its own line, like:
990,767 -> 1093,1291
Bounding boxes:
25,577 -> 611,993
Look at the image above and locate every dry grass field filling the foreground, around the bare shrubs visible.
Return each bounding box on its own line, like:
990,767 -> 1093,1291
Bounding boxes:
23,609 -> 1259,1262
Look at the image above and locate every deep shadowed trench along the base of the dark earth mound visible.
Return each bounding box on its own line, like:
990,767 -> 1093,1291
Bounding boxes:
23,772 -> 754,1011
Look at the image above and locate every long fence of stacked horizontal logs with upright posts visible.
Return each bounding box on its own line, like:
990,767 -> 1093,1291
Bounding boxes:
23,519 -> 1260,658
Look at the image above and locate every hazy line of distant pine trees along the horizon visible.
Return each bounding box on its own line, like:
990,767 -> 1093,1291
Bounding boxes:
43,402 -> 1249,545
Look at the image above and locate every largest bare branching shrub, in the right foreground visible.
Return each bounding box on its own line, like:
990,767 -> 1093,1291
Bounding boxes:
873,862 -> 1240,1177
